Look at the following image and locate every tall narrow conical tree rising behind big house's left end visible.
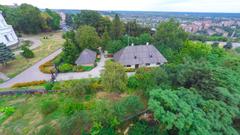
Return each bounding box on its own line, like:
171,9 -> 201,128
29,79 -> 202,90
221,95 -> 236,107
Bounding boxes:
111,14 -> 125,40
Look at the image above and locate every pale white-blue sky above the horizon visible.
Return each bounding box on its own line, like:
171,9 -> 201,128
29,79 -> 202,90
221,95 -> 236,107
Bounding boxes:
0,0 -> 240,13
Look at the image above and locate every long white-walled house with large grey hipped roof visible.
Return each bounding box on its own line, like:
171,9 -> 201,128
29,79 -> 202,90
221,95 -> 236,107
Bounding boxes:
113,45 -> 167,68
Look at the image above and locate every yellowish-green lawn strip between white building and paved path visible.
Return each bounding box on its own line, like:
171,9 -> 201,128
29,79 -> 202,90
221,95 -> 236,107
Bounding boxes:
0,32 -> 64,78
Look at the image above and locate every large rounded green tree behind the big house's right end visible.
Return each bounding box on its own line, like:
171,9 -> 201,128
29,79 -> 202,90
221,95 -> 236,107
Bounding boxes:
154,19 -> 188,51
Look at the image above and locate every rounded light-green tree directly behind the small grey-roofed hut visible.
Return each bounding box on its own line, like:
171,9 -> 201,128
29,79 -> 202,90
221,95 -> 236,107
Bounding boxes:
75,25 -> 100,50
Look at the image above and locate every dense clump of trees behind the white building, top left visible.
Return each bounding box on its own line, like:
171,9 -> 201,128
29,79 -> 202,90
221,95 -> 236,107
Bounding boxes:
0,4 -> 61,34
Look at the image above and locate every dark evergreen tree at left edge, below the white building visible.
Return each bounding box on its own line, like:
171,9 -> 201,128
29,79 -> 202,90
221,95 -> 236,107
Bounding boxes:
0,43 -> 15,64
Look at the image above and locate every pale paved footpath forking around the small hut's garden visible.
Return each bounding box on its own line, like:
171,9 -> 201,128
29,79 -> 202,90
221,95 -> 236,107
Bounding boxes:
0,49 -> 107,88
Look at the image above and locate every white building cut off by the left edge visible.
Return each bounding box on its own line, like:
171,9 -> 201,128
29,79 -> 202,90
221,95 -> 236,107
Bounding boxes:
0,11 -> 18,47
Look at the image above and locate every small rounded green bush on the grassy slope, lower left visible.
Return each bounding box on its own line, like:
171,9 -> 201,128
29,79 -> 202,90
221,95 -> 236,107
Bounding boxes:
40,100 -> 58,115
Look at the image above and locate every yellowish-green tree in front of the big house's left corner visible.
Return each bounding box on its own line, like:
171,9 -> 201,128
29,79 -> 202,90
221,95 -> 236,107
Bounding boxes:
101,61 -> 127,92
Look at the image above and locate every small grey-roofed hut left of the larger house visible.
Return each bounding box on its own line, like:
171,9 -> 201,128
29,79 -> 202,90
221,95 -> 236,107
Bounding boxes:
75,49 -> 97,66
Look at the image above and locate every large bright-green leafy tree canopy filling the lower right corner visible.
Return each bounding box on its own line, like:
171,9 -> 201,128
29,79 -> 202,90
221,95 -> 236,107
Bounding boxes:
149,88 -> 239,134
